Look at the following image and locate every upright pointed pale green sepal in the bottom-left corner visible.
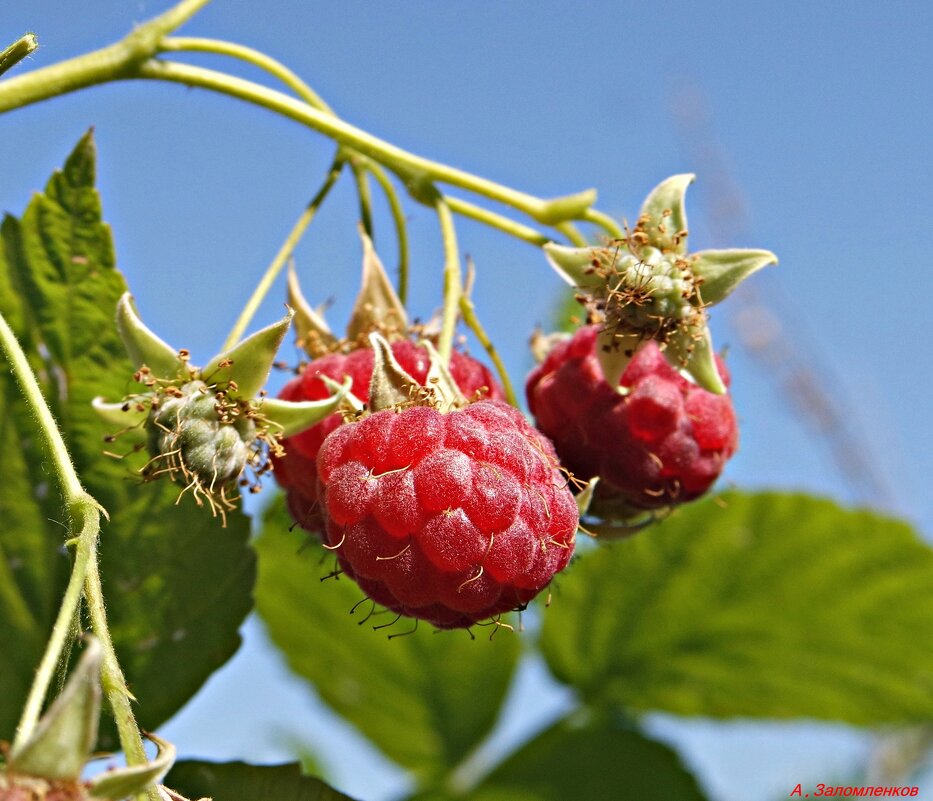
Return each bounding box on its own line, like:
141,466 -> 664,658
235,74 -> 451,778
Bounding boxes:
8,637 -> 103,781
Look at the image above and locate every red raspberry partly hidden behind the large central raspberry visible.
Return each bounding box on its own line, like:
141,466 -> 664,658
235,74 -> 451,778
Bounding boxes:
274,339 -> 504,532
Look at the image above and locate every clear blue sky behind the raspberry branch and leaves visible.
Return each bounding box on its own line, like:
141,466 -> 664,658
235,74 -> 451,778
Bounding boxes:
0,0 -> 933,799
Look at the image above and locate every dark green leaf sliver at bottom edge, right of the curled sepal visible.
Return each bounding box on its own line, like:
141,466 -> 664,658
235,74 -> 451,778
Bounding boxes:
163,760 -> 352,801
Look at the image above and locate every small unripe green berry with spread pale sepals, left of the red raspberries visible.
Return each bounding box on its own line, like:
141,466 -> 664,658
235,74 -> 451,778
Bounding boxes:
94,294 -> 347,520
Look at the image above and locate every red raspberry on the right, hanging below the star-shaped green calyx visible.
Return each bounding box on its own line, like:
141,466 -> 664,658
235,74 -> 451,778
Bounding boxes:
526,325 -> 738,510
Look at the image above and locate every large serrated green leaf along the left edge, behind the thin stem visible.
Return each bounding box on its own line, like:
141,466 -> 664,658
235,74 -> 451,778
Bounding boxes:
0,134 -> 255,747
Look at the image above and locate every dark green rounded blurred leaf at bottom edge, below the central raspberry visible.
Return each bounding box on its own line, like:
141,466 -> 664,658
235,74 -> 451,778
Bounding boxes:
469,721 -> 705,801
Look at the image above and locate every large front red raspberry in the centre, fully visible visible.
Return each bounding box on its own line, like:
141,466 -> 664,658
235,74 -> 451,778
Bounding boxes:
317,400 -> 577,629
